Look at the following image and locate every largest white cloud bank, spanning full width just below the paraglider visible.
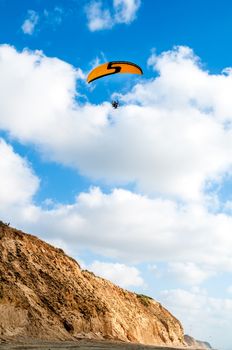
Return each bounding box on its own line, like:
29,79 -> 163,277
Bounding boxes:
3,45 -> 232,201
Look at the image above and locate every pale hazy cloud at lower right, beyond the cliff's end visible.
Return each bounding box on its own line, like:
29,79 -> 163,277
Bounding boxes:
161,288 -> 232,350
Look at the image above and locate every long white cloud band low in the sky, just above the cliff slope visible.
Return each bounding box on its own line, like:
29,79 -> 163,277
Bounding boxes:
34,188 -> 232,272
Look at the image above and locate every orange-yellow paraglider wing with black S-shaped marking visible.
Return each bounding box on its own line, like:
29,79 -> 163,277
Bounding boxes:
87,61 -> 143,83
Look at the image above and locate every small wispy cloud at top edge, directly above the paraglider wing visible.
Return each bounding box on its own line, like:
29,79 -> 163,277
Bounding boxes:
85,0 -> 140,32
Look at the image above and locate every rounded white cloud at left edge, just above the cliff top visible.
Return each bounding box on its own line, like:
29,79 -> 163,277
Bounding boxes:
0,139 -> 39,227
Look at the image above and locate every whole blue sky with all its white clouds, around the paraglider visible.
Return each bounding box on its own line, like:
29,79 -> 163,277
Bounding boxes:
0,0 -> 232,349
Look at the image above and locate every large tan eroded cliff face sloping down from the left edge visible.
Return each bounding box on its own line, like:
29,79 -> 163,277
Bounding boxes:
0,222 -> 185,346
